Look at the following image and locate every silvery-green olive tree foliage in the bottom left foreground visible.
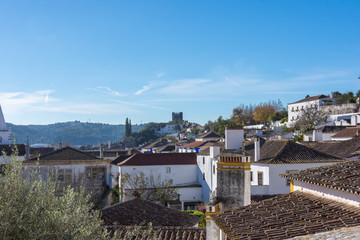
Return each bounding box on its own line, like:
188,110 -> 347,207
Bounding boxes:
0,147 -> 109,239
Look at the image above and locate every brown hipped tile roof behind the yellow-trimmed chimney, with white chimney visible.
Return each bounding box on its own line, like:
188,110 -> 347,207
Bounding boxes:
245,140 -> 344,164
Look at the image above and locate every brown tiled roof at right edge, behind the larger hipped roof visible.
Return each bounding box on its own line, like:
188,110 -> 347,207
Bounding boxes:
301,136 -> 360,158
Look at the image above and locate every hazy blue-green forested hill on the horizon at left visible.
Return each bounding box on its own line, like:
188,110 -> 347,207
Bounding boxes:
7,121 -> 146,145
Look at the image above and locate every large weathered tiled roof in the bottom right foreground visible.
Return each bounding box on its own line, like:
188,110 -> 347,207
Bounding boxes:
213,192 -> 360,239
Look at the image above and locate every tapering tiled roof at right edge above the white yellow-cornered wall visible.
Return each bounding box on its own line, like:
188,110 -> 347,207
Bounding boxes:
281,160 -> 360,195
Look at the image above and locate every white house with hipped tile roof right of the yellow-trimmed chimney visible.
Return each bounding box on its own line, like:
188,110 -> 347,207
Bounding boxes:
245,140 -> 345,195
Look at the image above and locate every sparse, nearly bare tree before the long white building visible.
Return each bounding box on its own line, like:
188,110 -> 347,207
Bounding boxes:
120,172 -> 177,203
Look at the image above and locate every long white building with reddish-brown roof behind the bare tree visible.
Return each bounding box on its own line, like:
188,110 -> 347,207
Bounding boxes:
117,153 -> 202,210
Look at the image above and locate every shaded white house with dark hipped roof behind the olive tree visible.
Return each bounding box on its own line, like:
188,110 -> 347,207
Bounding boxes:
23,147 -> 118,208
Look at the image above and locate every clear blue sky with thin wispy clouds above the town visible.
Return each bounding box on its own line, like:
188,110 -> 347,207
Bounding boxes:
0,0 -> 360,124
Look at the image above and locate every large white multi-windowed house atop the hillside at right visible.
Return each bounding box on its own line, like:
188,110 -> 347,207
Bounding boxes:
288,95 -> 334,125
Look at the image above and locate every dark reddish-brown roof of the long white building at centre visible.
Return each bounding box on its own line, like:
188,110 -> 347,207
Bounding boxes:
118,153 -> 196,166
